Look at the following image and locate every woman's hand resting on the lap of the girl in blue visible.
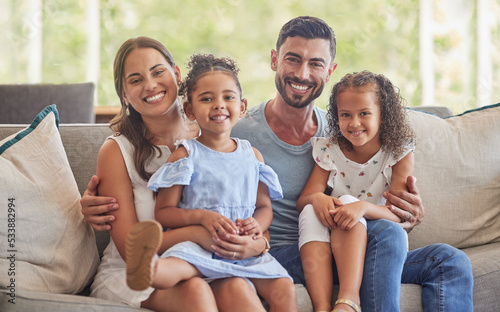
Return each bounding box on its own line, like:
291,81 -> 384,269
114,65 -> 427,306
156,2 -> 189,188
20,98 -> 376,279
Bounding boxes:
210,234 -> 269,260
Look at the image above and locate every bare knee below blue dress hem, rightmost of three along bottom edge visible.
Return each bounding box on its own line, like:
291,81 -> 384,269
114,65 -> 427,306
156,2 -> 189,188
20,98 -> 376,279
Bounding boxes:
251,277 -> 298,312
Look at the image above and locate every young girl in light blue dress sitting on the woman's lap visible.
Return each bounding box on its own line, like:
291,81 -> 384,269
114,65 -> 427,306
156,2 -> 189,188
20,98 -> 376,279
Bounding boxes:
126,54 -> 297,311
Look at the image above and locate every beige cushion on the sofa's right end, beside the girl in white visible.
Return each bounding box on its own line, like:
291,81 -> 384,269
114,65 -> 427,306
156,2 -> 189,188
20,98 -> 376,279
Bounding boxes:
408,104 -> 500,249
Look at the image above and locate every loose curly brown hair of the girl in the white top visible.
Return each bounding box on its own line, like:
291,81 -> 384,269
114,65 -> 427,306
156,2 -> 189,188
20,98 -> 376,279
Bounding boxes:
327,70 -> 415,157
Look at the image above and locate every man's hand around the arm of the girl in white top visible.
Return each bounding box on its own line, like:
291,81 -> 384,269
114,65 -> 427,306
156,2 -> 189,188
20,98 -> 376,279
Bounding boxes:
384,176 -> 425,233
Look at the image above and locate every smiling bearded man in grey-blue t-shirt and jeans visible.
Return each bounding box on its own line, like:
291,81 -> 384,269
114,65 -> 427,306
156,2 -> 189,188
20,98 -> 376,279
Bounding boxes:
82,16 -> 473,311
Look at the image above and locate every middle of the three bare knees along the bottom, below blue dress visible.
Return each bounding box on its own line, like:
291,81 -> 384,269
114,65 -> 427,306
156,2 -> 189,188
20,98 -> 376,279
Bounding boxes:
210,277 -> 266,312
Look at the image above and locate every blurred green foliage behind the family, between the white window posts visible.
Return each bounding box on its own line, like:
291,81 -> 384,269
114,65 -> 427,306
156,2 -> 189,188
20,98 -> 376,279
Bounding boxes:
99,0 -> 420,107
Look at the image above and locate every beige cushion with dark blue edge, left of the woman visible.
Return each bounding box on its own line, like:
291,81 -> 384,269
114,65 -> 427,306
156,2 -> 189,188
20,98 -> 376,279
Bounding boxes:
0,105 -> 99,294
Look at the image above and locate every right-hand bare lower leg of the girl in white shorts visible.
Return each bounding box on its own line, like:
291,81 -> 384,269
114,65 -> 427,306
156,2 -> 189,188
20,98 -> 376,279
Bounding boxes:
331,222 -> 367,311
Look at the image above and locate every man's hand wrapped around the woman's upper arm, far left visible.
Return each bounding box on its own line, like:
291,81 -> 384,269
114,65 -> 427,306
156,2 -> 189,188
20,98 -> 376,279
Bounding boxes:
80,175 -> 118,231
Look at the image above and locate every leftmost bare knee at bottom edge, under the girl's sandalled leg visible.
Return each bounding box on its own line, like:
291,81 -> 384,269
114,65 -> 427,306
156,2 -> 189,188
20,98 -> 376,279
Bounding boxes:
141,277 -> 218,312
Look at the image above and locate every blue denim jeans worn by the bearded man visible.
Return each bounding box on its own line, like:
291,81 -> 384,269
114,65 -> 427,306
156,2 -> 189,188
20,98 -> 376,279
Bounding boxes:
270,220 -> 473,312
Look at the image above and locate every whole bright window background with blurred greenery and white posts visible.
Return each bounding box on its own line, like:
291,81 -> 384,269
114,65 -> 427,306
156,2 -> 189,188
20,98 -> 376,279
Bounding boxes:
0,0 -> 500,113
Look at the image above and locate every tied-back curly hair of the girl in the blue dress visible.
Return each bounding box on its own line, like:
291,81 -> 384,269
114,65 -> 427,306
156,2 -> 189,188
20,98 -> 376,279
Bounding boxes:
179,54 -> 242,103
